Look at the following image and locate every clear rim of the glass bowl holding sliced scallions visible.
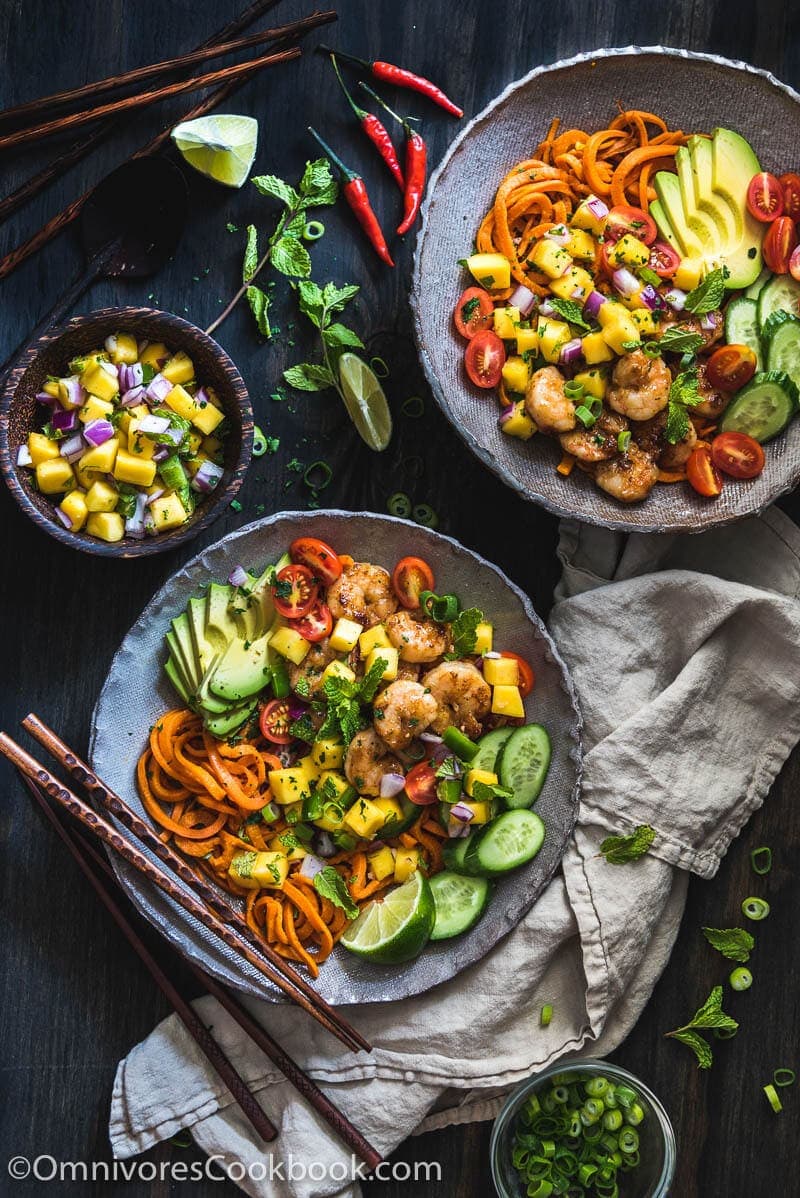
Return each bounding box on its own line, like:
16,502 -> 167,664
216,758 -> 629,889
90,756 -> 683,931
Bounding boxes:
489,1057 -> 678,1198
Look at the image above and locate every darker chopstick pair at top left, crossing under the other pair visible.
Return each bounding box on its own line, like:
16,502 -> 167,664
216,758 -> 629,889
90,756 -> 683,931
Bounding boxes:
0,0 -> 337,279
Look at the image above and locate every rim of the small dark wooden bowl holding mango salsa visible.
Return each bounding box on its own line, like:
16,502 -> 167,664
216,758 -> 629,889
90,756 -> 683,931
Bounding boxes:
0,304 -> 254,558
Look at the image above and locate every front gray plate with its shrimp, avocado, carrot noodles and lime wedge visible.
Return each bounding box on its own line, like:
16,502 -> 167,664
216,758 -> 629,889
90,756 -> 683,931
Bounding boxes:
92,512 -> 581,1003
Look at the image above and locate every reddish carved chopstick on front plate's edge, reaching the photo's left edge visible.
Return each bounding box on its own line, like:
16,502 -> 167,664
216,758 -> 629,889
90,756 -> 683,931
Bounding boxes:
0,732 -> 366,1047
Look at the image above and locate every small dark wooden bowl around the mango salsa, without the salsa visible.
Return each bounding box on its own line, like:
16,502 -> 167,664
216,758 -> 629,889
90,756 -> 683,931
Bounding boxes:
0,308 -> 253,557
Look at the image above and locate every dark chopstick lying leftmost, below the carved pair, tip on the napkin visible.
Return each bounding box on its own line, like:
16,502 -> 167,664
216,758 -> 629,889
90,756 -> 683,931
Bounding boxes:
20,773 -> 278,1143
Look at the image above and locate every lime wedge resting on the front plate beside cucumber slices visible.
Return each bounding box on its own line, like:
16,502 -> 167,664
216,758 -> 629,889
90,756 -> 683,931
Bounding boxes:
341,870 -> 436,966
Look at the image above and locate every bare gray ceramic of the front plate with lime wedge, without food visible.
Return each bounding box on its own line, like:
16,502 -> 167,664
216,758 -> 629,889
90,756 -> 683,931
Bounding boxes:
91,512 -> 581,1003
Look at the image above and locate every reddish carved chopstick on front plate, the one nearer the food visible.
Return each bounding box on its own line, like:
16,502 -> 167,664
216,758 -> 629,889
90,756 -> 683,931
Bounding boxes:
22,712 -> 371,1052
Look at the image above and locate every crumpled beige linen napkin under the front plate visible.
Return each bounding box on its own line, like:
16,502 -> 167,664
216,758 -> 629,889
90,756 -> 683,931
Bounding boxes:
110,509 -> 800,1198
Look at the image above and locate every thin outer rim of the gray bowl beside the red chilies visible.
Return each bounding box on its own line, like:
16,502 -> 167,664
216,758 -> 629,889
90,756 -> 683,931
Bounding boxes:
416,43 -> 800,536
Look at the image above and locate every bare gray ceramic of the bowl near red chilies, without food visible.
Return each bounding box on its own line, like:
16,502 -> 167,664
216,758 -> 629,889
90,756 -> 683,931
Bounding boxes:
411,47 -> 800,532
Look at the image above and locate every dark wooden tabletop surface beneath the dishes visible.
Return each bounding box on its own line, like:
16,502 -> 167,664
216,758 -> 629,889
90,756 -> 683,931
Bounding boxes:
0,0 -> 800,1198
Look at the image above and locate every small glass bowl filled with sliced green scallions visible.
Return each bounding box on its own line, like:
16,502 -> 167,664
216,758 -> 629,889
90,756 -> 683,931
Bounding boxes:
491,1060 -> 675,1198
